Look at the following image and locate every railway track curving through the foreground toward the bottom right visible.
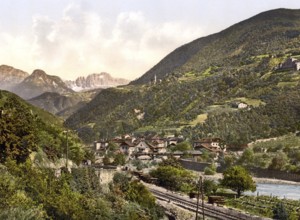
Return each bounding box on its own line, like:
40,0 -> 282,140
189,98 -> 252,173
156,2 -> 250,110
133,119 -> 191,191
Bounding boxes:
149,187 -> 268,220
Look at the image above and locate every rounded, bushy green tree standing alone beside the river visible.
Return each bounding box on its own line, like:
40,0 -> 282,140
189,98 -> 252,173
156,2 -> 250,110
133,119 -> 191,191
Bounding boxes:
221,166 -> 256,197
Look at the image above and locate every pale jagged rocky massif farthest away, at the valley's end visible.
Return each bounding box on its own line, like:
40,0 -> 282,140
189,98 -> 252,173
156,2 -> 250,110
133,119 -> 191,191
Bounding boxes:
66,72 -> 129,91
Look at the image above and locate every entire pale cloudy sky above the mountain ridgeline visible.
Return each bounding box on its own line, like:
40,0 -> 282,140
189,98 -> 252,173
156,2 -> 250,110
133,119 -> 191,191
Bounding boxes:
0,0 -> 300,80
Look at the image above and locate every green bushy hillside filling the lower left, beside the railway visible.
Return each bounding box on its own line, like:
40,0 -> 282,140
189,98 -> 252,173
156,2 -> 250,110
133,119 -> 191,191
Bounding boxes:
0,90 -> 164,220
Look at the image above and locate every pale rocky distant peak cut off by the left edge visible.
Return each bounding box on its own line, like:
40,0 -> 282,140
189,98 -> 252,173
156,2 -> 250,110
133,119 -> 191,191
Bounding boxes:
0,65 -> 29,90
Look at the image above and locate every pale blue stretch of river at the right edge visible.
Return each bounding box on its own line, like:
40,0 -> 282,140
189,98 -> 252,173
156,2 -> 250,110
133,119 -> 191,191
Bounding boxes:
245,183 -> 300,200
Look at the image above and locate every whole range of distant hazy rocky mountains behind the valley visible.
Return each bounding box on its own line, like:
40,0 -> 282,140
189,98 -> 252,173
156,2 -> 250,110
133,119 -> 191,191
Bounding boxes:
0,65 -> 129,117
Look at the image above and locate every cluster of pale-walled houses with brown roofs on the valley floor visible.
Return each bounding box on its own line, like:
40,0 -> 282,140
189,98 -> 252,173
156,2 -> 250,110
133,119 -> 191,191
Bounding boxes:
94,135 -> 226,163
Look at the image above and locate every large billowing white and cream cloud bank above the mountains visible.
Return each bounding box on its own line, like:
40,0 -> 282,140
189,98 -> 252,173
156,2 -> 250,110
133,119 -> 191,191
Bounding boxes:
0,4 -> 202,79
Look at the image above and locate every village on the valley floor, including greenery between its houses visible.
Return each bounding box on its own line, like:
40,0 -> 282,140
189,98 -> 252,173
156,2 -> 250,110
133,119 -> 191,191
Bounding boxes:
92,135 -> 227,164
